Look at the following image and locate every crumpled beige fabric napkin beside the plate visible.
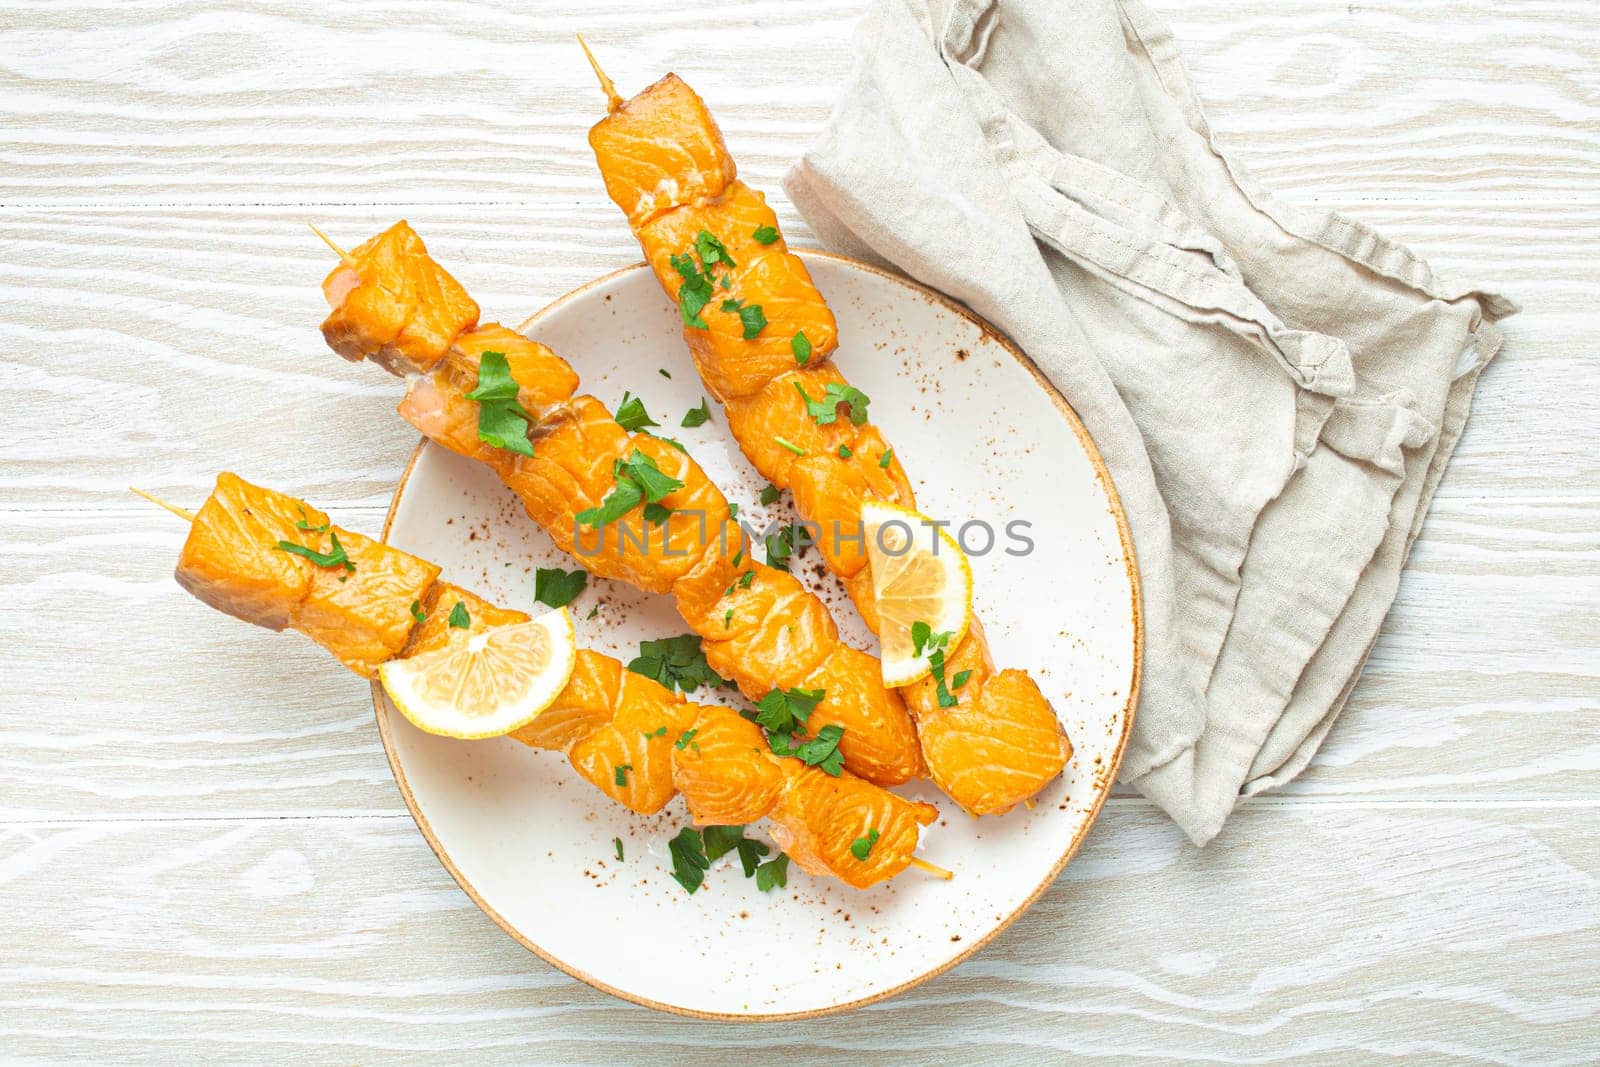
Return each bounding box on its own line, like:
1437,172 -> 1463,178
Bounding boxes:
786,0 -> 1515,843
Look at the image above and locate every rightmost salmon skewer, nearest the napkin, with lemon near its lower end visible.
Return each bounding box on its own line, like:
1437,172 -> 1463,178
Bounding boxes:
584,45 -> 1072,814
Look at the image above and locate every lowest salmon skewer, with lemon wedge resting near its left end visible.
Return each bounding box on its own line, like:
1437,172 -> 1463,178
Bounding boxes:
141,472 -> 949,888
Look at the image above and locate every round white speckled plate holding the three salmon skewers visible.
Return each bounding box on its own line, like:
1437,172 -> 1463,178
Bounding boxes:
373,253 -> 1142,1019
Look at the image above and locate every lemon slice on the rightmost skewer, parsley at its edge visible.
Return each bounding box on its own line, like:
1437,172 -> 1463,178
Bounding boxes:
861,501 -> 973,686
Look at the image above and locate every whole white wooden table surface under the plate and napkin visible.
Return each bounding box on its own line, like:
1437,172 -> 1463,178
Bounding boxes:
0,0 -> 1600,1064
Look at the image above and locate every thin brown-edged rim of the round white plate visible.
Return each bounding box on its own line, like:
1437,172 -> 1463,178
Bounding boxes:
371,248 -> 1144,1022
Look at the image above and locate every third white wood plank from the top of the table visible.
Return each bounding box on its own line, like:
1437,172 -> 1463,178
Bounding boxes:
0,489 -> 1600,819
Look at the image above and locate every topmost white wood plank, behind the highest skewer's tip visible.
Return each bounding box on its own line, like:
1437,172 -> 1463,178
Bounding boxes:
0,0 -> 1600,205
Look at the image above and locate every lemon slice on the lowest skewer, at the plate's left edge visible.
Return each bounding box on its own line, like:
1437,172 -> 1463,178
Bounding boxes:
378,608 -> 578,737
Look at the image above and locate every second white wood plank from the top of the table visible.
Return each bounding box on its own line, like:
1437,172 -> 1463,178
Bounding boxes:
0,203 -> 1600,509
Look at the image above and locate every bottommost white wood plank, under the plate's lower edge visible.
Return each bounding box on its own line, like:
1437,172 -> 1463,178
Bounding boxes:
0,801 -> 1600,1064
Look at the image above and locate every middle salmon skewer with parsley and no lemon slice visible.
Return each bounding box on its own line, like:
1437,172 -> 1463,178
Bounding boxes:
305,221 -> 923,785
